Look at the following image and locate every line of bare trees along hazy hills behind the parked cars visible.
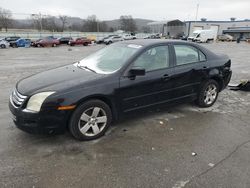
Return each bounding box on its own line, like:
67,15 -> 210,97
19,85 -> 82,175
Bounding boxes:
0,7 -> 146,32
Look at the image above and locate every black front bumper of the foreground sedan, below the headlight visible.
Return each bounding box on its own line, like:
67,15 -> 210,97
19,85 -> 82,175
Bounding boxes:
9,99 -> 70,134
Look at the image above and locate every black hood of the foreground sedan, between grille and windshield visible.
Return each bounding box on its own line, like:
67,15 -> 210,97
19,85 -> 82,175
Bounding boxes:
16,65 -> 105,96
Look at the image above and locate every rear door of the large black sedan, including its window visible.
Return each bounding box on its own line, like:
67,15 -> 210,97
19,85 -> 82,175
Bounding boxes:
172,44 -> 209,98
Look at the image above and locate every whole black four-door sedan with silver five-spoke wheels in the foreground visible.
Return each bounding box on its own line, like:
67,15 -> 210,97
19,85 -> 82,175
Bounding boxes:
9,40 -> 232,140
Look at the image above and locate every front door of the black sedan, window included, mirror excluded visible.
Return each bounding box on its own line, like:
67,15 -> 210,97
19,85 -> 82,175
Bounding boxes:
119,45 -> 174,112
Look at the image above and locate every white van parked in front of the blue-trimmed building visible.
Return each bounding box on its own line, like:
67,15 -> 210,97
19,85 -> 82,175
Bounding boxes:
188,30 -> 216,42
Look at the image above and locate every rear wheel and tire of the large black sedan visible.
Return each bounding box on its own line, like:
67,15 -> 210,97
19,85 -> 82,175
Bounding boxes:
196,80 -> 219,108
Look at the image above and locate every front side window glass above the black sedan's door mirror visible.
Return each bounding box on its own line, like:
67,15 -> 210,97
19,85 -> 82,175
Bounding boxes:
134,46 -> 169,72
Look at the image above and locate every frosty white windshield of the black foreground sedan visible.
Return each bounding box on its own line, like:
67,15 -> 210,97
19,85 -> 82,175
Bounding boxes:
77,44 -> 142,74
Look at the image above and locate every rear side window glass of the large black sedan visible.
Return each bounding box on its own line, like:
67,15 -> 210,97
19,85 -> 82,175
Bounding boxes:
174,45 -> 206,65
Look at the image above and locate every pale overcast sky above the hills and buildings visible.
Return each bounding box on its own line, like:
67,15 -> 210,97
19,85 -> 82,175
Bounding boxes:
0,0 -> 250,20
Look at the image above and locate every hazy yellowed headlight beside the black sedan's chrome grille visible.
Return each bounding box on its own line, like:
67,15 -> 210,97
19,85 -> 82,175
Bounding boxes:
26,92 -> 55,112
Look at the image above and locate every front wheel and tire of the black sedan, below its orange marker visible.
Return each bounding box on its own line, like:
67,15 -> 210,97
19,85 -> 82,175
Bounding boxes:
69,100 -> 112,141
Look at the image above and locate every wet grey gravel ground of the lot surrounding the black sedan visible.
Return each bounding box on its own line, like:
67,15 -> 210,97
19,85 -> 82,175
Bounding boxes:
0,43 -> 250,188
